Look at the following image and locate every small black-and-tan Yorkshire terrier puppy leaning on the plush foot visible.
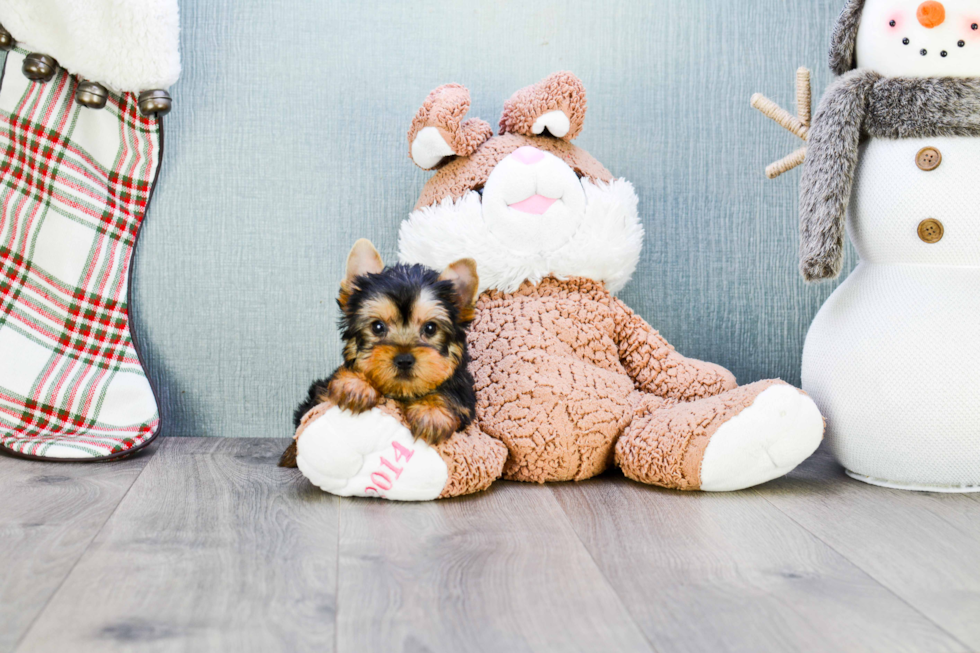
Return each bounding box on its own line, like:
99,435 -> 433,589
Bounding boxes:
279,239 -> 480,467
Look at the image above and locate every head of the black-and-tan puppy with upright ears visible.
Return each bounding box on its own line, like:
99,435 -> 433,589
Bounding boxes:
337,239 -> 479,399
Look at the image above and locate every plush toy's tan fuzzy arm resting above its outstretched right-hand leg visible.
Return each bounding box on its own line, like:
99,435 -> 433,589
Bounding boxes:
612,297 -> 738,401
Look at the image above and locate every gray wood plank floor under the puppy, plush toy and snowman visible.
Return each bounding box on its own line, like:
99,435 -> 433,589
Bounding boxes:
0,438 -> 980,653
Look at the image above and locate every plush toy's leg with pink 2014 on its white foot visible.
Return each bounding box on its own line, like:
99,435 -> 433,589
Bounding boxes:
296,404 -> 507,501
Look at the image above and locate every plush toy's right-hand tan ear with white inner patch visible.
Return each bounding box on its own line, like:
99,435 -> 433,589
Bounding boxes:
500,72 -> 586,141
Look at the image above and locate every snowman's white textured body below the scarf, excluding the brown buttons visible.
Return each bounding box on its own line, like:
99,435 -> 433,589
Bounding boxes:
803,138 -> 980,491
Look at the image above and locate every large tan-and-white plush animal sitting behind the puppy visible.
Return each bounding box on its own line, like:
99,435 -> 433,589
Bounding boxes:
296,72 -> 824,501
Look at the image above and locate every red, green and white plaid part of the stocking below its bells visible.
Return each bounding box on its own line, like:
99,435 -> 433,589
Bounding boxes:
0,50 -> 162,459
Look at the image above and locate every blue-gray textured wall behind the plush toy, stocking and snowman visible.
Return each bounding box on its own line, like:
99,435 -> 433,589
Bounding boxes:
132,0 -> 853,437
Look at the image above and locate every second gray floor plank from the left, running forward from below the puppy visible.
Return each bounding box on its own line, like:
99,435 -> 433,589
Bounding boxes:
16,438 -> 340,652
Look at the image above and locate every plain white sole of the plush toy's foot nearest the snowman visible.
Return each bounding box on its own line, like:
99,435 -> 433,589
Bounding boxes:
700,383 -> 824,492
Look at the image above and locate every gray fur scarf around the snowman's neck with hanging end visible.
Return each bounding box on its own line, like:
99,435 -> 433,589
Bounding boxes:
800,70 -> 980,281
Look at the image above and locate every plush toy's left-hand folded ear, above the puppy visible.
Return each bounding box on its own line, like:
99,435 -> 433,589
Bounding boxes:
408,84 -> 493,170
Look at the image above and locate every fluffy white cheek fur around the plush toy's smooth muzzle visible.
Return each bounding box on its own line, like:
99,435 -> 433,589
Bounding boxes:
398,179 -> 643,293
